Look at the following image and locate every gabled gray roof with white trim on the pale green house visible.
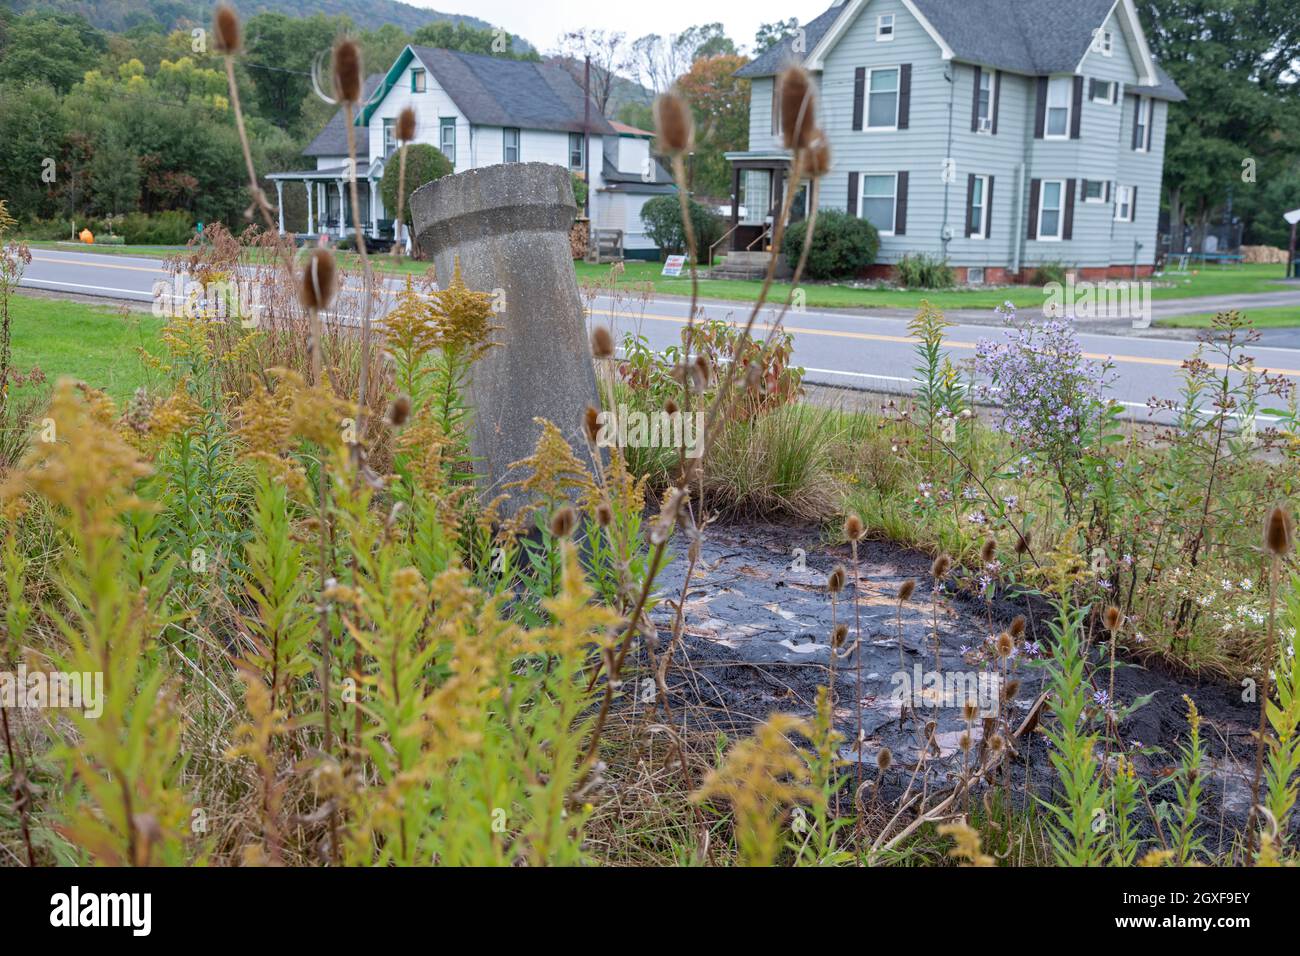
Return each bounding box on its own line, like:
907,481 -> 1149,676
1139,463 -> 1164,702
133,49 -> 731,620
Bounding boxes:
737,0 -> 1186,100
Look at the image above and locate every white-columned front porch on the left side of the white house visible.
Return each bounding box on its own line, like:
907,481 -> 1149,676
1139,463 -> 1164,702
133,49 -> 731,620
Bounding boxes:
267,163 -> 393,242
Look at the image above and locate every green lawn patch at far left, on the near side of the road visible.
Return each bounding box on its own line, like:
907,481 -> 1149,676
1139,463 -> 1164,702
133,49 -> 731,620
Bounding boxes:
9,295 -> 163,405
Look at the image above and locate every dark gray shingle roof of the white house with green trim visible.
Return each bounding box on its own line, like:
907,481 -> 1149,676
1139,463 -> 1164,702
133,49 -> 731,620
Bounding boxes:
412,47 -> 614,135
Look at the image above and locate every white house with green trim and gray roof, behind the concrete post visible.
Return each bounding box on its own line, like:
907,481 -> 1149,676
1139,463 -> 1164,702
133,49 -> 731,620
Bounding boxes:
268,46 -> 672,255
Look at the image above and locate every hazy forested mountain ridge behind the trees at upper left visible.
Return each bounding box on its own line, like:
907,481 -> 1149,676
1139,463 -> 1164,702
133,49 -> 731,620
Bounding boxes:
7,0 -> 533,52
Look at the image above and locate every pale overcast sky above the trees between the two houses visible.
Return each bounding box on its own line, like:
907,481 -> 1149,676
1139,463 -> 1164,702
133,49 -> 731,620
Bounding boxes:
406,0 -> 831,53
